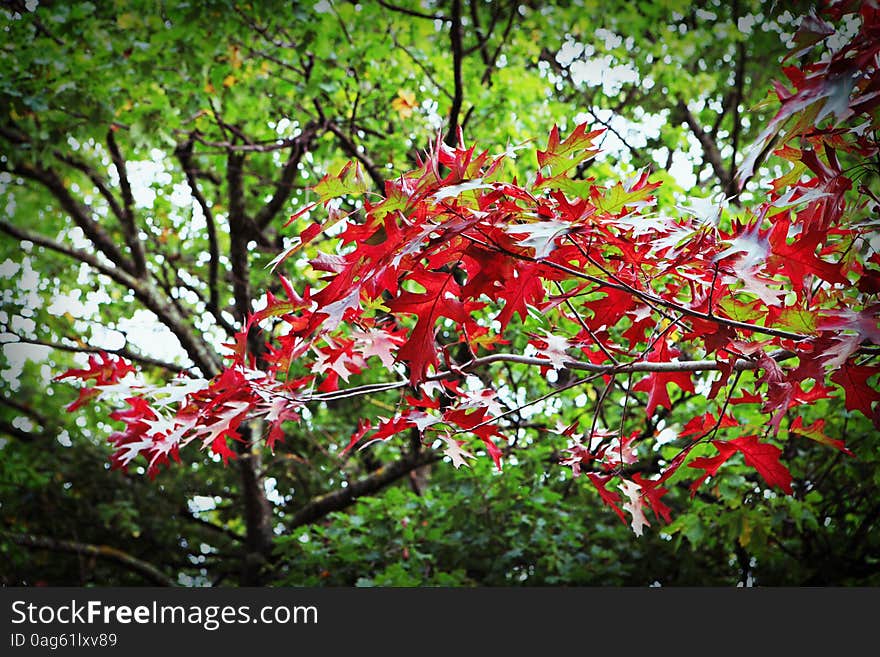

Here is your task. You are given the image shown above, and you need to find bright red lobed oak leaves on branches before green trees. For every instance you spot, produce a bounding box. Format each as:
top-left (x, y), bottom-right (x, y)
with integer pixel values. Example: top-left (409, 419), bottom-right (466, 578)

top-left (63, 3), bottom-right (880, 534)
